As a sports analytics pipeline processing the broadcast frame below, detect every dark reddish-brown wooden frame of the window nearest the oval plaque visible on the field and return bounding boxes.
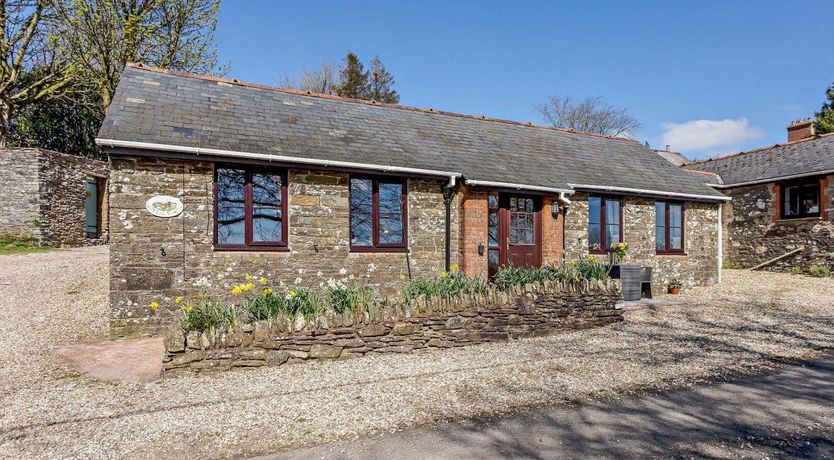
[213,164,289,252]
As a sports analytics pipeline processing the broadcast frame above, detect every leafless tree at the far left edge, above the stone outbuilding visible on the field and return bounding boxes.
[0,0,74,147]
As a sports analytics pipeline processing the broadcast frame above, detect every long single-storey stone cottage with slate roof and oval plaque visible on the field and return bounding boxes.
[97,65,726,336]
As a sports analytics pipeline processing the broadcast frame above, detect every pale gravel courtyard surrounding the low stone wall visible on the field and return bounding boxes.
[0,247,834,458]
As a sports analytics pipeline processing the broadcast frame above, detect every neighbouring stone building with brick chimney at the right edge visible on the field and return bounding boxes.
[685,119,834,271]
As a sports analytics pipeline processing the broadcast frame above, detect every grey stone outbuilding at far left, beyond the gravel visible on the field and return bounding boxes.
[0,148,110,246]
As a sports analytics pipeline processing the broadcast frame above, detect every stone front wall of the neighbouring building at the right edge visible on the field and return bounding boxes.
[722,176,834,271]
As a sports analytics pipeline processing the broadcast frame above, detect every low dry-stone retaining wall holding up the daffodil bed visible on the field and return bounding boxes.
[163,280,623,376]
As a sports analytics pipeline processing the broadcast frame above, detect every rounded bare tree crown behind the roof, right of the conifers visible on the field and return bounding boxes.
[538,96,640,136]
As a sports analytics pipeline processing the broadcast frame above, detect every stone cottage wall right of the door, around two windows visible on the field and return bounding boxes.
[565,193,718,294]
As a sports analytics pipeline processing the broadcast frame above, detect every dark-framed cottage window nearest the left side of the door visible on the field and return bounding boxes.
[350,178,408,251]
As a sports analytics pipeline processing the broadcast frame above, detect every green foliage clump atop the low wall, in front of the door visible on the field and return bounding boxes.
[493,258,609,289]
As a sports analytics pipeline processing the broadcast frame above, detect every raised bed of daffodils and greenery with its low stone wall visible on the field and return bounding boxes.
[164,262,622,375]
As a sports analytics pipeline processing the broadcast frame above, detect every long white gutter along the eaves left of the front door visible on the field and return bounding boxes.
[96,138,461,187]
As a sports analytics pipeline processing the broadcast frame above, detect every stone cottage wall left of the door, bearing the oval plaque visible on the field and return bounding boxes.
[110,156,460,336]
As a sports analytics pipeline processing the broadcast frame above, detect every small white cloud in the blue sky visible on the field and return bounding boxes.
[660,118,764,152]
